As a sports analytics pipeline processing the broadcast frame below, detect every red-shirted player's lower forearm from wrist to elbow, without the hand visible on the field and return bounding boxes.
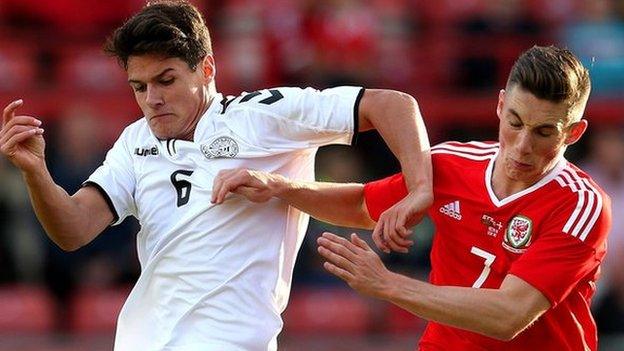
[381,273,536,340]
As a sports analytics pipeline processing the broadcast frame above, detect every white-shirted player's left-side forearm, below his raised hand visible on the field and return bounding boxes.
[22,166,95,251]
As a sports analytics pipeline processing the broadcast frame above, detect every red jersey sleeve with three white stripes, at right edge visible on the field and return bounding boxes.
[509,193,611,307]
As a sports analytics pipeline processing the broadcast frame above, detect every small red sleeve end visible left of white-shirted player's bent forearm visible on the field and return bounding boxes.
[364,173,407,221]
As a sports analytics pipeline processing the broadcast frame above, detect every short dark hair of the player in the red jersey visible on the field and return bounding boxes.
[507,45,591,108]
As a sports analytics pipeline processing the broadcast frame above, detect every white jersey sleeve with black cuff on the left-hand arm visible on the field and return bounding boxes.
[83,130,136,225]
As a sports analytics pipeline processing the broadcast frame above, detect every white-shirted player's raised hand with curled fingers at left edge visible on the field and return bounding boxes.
[0,99,45,171]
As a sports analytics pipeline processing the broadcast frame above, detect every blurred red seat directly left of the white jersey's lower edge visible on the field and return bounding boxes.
[69,289,129,334]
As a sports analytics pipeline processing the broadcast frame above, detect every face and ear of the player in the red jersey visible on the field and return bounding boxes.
[495,87,587,187]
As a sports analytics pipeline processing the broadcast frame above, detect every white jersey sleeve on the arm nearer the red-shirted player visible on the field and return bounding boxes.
[226,86,364,151]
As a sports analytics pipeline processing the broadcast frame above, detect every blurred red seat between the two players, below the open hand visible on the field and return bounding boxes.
[284,288,372,336]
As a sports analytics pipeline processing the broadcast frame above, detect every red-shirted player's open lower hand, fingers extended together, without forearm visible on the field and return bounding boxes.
[317,233,391,298]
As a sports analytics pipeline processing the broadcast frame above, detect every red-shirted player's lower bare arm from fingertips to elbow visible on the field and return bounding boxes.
[318,233,550,340]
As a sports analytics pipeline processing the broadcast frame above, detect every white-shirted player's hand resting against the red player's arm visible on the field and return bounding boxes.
[373,191,432,253]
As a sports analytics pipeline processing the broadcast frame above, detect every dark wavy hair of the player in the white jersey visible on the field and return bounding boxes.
[104,1,212,70]
